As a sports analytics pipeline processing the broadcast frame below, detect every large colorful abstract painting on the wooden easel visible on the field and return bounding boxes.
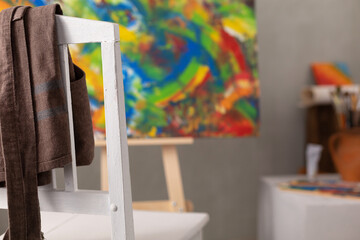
[0,0,260,138]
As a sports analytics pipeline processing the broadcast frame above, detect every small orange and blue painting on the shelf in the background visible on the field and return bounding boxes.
[311,62,353,85]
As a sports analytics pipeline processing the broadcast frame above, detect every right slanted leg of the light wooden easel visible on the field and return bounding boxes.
[162,145,187,212]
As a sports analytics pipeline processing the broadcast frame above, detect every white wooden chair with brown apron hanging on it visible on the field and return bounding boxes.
[0,16,208,240]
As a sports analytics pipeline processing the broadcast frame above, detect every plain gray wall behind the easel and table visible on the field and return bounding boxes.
[0,0,360,240]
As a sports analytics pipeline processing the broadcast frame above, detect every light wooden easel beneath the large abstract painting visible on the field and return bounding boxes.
[95,138,194,212]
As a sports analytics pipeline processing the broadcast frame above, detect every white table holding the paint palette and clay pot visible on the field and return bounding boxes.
[258,175,360,240]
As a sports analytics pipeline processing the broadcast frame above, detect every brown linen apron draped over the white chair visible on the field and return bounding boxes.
[0,5,94,240]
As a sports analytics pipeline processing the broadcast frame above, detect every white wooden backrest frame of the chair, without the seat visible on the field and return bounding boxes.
[0,16,134,240]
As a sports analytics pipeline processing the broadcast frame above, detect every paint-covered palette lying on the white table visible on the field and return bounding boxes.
[279,180,360,200]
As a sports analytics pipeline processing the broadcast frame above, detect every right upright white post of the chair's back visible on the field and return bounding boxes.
[101,40,135,240]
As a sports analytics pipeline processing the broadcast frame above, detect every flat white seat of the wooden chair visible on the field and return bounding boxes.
[1,211,209,240]
